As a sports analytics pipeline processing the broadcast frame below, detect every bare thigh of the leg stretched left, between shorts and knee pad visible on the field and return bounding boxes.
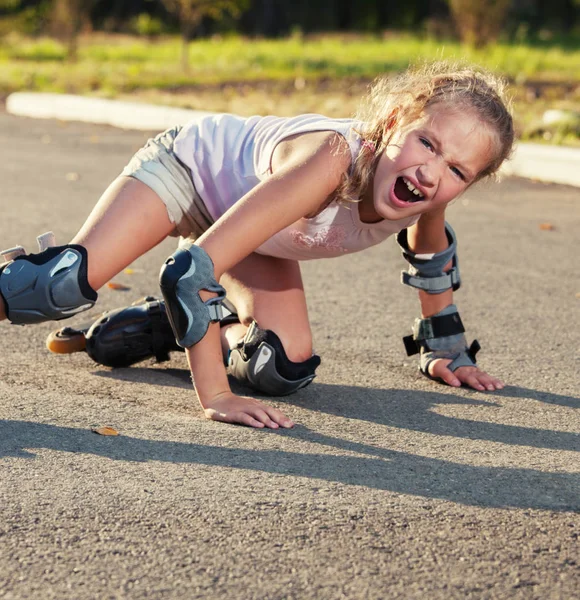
[0,177,175,320]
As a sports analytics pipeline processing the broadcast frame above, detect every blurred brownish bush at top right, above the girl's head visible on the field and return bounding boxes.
[447,0,511,48]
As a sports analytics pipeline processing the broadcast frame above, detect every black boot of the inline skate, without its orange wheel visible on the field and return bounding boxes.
[86,296,183,367]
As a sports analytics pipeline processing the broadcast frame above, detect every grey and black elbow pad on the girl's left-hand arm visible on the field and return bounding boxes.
[159,244,226,348]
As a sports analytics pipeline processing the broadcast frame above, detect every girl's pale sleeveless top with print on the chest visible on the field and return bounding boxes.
[174,114,417,260]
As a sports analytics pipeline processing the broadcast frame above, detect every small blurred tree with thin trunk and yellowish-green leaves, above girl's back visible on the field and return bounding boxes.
[162,0,250,71]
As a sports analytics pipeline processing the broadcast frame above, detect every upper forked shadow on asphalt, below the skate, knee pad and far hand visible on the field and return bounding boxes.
[97,367,580,452]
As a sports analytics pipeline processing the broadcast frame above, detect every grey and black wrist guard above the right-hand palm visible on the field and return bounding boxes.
[403,304,481,380]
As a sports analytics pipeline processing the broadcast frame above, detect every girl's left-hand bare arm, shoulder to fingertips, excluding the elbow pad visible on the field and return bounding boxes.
[187,132,350,427]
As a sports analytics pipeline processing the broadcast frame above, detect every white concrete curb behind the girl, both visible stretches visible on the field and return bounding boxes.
[6,92,580,187]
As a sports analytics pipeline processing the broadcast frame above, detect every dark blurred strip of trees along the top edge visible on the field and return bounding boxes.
[0,0,580,44]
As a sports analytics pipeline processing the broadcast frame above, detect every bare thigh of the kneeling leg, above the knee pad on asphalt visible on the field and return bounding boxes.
[220,253,312,362]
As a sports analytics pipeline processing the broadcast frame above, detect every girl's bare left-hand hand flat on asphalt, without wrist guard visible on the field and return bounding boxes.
[203,392,294,429]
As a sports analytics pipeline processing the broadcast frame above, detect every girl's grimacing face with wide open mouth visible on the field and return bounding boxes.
[360,106,493,221]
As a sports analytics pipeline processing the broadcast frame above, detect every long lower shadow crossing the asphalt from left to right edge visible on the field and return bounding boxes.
[0,420,580,511]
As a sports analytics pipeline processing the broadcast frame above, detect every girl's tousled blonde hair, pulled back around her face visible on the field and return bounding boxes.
[336,61,515,202]
